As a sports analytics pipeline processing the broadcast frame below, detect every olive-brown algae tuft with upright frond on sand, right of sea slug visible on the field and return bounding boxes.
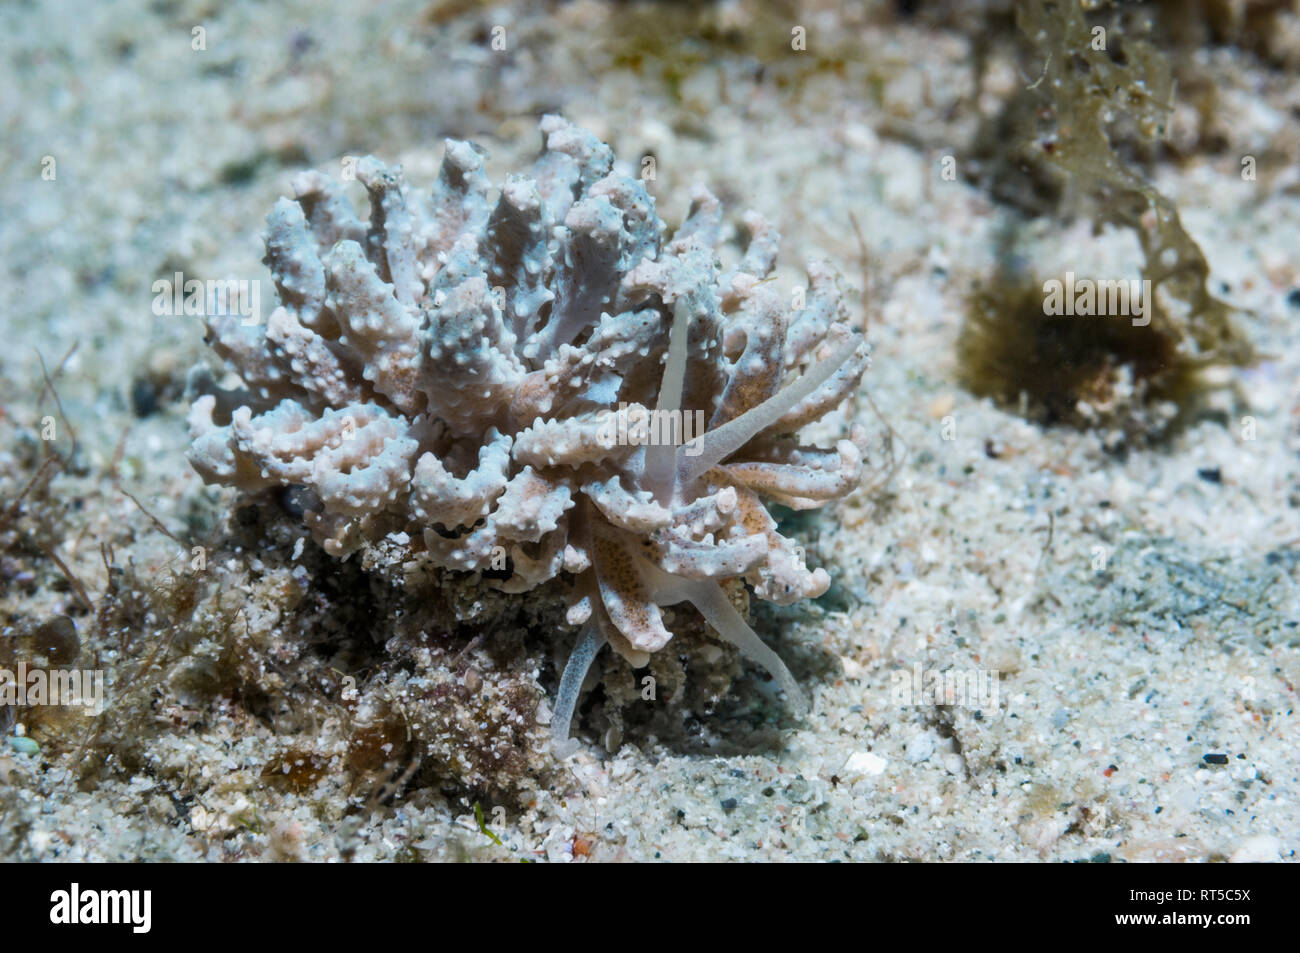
[959,0,1255,442]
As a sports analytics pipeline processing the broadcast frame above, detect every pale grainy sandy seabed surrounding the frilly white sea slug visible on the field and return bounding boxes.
[0,0,1300,861]
